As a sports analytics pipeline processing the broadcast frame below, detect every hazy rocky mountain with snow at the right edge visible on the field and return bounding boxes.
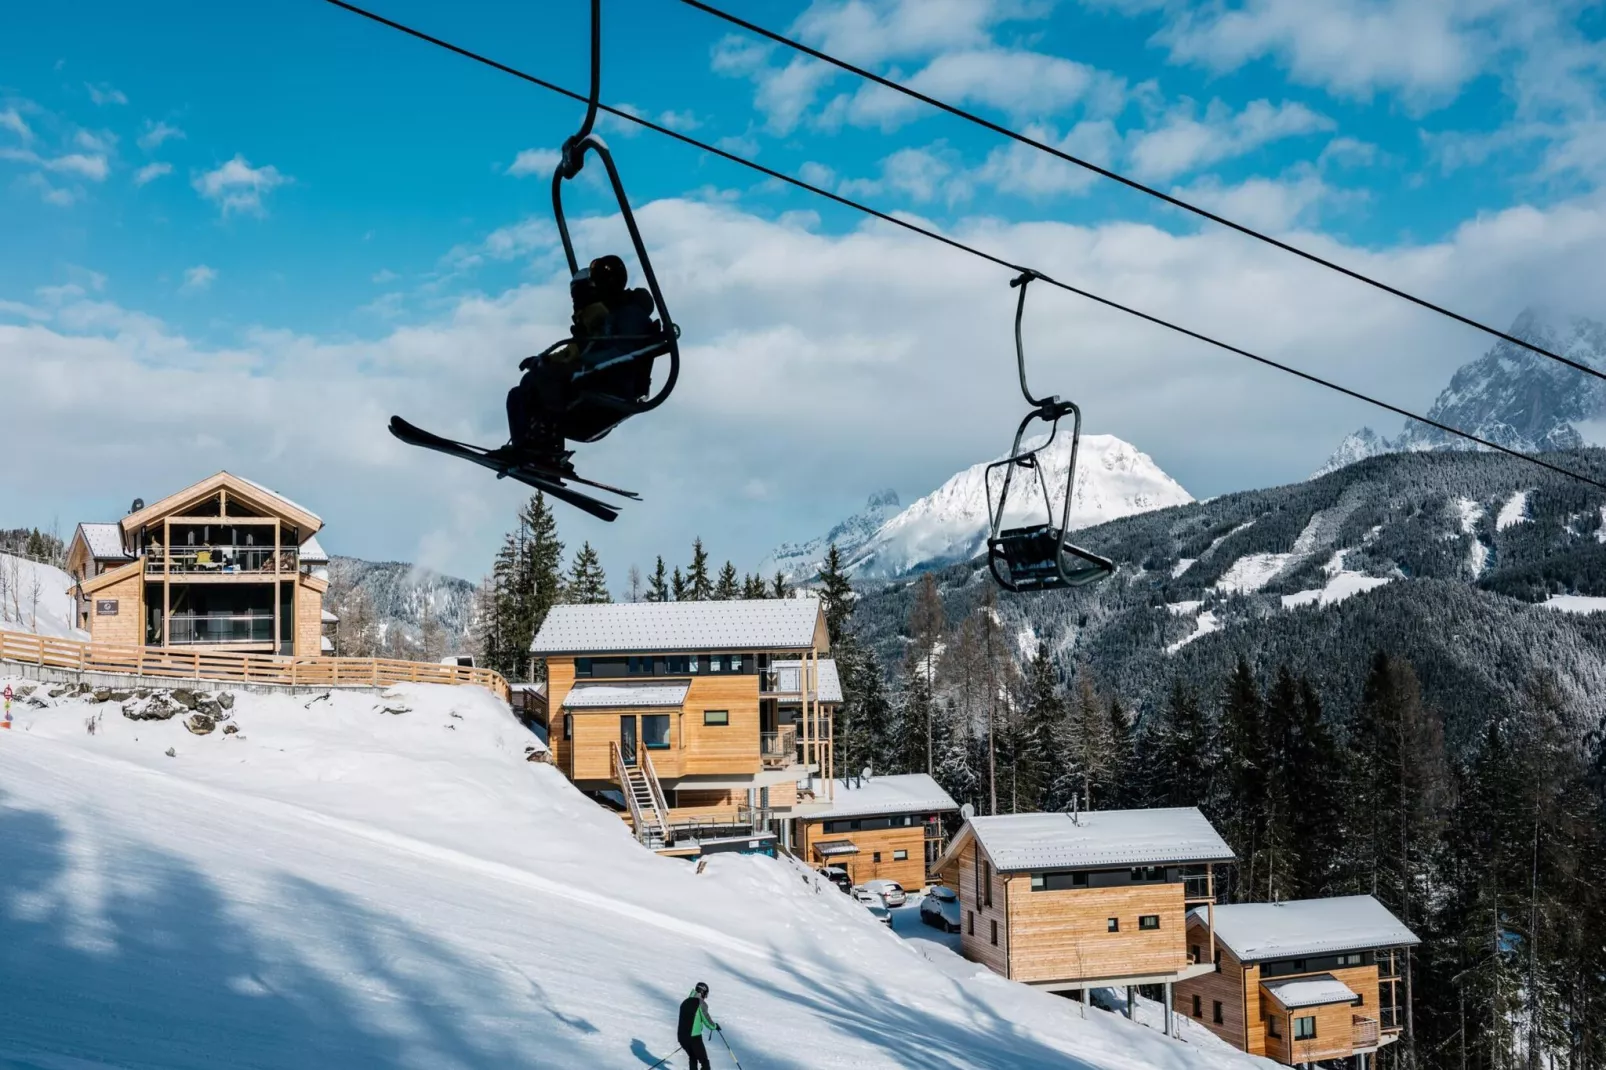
[1315,308,1606,476]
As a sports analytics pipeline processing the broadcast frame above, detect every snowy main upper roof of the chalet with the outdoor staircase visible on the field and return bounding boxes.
[530,598,819,654]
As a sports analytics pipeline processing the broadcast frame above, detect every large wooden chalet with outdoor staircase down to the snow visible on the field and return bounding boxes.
[530,598,840,855]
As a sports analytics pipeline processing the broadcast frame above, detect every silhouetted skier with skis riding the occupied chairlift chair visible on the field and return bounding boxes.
[390,0,681,521]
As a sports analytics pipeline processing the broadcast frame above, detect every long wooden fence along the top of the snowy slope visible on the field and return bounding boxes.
[0,631,509,700]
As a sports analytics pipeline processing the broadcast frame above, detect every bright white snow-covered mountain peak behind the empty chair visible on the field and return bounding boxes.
[848,435,1193,580]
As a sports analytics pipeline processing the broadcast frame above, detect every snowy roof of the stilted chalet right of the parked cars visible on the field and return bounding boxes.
[970,807,1233,873]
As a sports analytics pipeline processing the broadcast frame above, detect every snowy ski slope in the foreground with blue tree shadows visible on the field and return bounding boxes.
[0,677,1270,1070]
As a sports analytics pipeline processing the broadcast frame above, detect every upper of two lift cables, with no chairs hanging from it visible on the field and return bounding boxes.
[679,0,1606,387]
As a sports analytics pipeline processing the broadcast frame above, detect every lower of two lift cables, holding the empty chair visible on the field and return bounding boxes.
[313,0,1606,490]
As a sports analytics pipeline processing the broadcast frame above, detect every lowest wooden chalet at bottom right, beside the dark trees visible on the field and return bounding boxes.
[1176,895,1418,1067]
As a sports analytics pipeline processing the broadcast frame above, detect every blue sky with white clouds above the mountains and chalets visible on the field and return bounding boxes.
[0,0,1606,577]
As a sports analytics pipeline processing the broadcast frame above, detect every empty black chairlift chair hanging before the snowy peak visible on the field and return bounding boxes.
[983,272,1115,591]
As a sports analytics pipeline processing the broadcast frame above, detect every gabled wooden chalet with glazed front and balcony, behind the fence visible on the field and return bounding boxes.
[67,472,329,657]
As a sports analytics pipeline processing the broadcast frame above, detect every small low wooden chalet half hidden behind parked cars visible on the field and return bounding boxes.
[795,773,959,892]
